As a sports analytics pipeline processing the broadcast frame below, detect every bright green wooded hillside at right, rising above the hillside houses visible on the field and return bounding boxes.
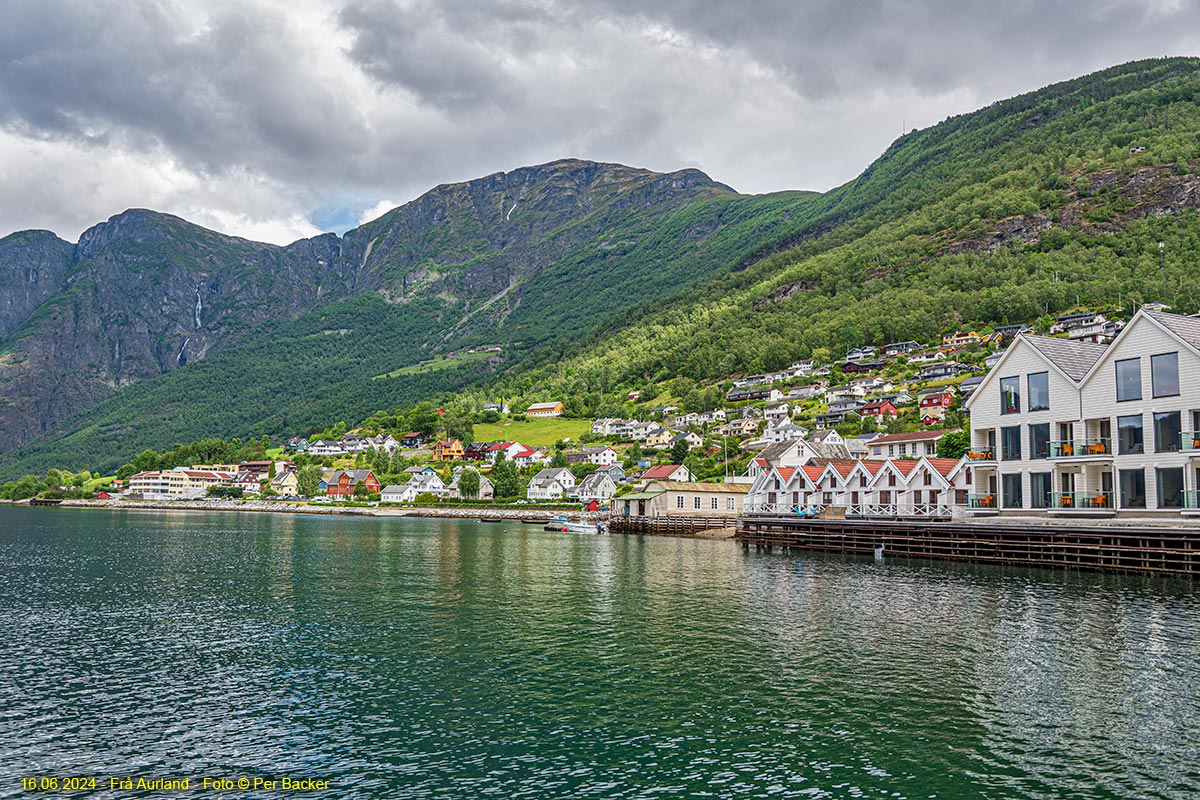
[484,59,1200,413]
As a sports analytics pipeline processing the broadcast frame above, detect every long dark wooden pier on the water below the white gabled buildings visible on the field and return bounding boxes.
[736,517,1200,576]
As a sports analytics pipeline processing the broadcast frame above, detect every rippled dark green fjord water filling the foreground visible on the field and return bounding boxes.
[0,509,1200,799]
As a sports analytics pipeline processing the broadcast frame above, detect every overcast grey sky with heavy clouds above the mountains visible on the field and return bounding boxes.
[0,0,1200,242]
